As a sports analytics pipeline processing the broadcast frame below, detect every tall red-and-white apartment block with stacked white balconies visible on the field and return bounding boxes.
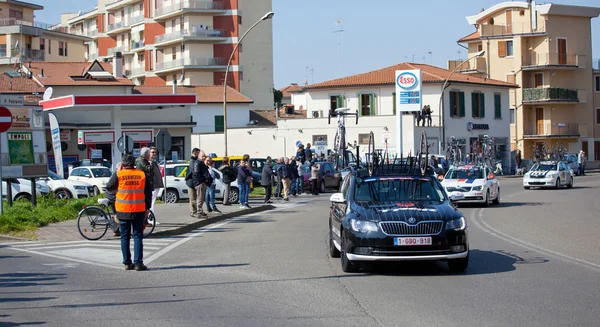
[63,0,273,108]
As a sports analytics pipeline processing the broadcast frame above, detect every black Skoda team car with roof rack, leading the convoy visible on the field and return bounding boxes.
[329,132,469,272]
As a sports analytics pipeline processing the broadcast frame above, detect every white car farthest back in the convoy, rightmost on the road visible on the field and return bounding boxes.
[523,161,575,190]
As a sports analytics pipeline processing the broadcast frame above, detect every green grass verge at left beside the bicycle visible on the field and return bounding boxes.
[0,196,103,238]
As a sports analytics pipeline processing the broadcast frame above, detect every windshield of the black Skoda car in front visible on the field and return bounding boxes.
[354,177,445,202]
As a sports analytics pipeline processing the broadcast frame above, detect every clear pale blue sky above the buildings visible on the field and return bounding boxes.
[30,0,600,88]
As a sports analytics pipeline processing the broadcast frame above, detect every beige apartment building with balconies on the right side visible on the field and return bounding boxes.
[448,1,600,160]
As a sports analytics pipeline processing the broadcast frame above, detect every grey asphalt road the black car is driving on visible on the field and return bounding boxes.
[0,175,600,326]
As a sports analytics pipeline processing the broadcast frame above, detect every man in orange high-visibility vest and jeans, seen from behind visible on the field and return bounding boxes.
[106,155,152,271]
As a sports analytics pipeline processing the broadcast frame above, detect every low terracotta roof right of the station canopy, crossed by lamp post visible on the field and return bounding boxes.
[133,85,254,103]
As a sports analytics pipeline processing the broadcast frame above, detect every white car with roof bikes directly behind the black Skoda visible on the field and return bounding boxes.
[442,165,500,206]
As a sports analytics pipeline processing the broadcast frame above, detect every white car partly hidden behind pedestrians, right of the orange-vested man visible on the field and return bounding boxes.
[157,163,246,204]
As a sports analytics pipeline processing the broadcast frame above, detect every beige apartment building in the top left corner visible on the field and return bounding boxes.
[0,0,89,72]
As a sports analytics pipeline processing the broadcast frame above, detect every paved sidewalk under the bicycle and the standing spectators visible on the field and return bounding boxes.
[32,198,276,242]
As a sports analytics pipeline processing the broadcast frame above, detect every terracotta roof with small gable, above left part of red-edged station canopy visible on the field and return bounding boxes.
[27,61,135,86]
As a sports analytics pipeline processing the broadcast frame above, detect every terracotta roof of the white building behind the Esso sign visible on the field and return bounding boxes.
[304,63,519,90]
